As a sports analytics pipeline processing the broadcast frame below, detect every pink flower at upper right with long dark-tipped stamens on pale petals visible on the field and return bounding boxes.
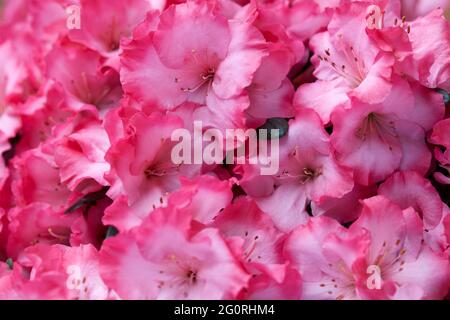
[295,1,394,123]
